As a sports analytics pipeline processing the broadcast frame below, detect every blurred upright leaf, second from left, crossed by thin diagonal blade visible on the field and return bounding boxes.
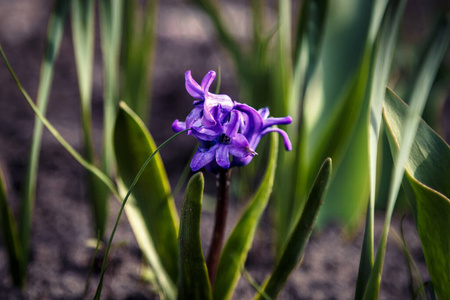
[71,0,108,237]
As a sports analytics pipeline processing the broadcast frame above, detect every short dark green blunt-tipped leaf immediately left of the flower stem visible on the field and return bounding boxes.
[178,173,212,299]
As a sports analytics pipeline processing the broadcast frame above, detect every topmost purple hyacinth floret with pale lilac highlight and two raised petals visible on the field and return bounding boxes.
[185,71,234,127]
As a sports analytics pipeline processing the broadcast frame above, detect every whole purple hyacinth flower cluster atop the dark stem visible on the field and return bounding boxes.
[172,71,292,173]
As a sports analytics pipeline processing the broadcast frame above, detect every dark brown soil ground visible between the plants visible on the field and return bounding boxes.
[0,0,448,299]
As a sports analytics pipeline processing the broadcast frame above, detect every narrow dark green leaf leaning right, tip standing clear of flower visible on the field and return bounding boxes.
[257,158,332,299]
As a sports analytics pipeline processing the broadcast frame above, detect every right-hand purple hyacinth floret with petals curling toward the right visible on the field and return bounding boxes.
[233,103,292,166]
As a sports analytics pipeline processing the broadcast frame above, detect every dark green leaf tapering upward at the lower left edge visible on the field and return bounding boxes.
[0,168,26,287]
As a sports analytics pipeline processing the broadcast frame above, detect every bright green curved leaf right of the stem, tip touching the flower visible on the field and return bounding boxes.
[213,134,278,300]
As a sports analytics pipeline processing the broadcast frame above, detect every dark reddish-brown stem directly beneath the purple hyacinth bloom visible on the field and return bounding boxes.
[207,169,231,286]
